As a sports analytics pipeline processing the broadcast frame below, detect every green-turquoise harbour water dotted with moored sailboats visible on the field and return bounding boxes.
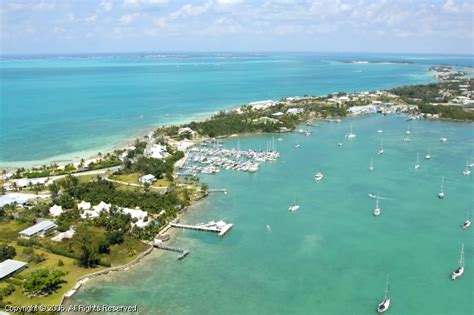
[70,115,474,315]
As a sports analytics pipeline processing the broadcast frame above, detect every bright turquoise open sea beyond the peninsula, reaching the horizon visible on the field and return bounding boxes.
[0,54,473,166]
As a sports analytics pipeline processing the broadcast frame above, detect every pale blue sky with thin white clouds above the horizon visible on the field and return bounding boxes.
[0,0,474,54]
